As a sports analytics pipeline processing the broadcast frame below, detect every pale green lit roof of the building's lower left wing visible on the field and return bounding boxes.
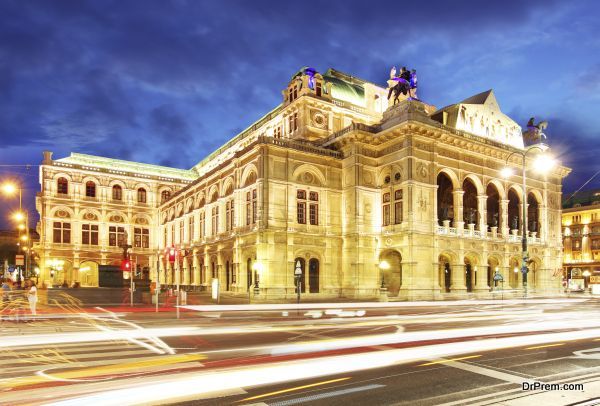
[55,152,198,180]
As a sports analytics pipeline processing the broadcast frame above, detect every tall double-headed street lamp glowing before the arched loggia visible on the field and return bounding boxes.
[501,143,555,295]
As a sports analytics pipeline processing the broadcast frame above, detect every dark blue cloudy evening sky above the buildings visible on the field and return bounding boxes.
[0,0,600,228]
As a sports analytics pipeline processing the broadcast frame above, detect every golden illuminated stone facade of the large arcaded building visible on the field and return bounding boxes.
[39,68,568,299]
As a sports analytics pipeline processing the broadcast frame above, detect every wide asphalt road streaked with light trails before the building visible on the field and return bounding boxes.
[0,299,600,405]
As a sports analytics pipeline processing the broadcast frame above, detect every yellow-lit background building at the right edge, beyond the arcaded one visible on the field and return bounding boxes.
[562,189,600,290]
